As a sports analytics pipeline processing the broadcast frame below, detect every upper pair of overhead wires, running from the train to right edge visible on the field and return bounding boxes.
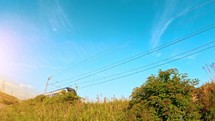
[48,24,215,86]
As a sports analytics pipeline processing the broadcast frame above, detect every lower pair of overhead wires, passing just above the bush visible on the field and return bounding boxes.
[79,41,215,89]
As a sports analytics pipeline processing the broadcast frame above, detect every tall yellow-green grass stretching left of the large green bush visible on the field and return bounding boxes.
[0,96,129,121]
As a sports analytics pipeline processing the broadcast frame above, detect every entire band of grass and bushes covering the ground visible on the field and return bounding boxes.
[0,69,215,121]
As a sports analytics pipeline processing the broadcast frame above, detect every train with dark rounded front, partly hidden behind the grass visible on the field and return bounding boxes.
[44,87,77,97]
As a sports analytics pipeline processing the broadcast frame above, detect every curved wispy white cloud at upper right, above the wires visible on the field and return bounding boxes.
[151,0,214,48]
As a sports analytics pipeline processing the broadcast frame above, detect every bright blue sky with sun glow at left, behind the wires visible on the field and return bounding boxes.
[0,0,215,98]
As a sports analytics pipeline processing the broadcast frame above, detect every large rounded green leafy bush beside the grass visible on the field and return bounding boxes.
[128,69,200,121]
